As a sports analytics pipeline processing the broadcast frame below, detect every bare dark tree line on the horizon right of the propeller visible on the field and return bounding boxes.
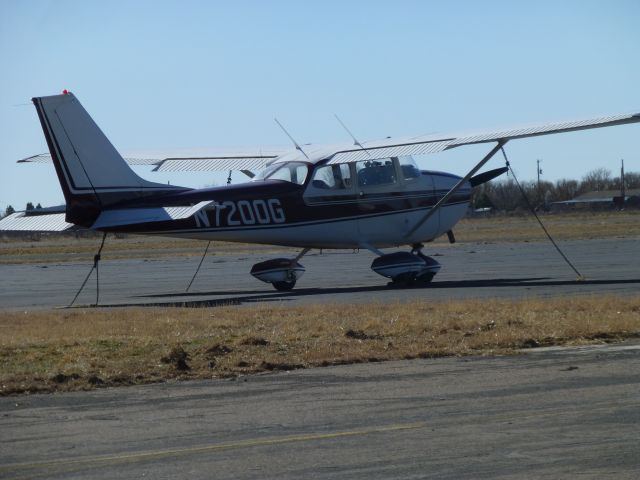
[471,168,640,212]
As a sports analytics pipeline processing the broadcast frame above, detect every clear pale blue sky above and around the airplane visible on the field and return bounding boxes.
[0,0,640,210]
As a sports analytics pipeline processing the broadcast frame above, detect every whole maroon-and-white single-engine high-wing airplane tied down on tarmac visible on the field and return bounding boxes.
[3,90,640,290]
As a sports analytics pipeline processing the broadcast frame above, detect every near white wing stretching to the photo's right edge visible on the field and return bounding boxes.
[328,113,640,164]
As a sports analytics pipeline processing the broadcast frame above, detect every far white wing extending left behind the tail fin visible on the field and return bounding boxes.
[18,148,291,172]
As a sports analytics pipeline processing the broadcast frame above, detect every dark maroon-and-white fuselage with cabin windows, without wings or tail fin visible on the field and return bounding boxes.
[102,158,471,248]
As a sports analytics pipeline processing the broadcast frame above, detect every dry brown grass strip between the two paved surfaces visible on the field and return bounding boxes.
[0,296,640,395]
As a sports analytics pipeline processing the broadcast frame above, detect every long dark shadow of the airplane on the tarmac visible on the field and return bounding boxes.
[87,277,640,308]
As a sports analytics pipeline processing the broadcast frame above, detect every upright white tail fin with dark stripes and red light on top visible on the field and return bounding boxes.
[32,91,184,227]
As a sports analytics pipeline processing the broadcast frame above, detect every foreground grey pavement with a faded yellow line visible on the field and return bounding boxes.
[0,344,640,479]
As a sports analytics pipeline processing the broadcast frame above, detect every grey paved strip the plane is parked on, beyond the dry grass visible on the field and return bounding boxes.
[0,238,640,309]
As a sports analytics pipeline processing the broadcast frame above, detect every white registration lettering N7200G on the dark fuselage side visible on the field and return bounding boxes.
[204,198,286,227]
